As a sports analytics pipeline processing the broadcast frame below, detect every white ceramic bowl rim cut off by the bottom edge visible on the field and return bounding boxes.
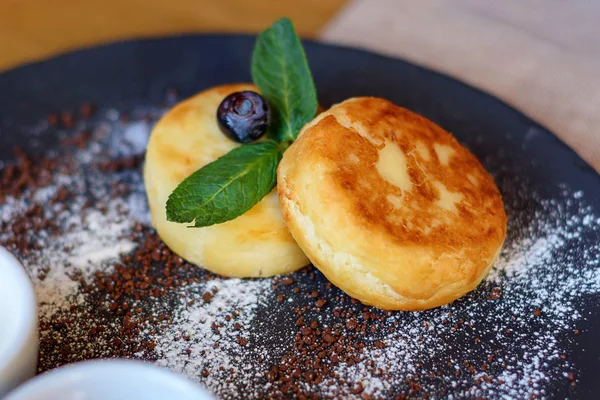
[4,360,214,400]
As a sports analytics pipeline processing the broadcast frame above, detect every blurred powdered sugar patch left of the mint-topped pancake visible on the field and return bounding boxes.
[0,110,149,319]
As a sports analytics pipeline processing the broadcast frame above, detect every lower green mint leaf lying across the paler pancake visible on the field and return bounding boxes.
[167,142,283,228]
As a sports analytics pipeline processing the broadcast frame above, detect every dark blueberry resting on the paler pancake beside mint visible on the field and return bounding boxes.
[217,90,270,143]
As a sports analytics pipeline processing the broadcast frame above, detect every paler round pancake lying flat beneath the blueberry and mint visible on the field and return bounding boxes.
[144,84,309,277]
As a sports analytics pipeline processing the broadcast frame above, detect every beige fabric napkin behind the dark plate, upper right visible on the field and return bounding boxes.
[322,0,600,172]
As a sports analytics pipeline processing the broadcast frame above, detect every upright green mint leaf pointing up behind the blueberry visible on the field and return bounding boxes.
[251,18,318,142]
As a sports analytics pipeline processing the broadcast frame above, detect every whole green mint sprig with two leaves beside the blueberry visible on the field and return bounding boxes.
[166,18,317,228]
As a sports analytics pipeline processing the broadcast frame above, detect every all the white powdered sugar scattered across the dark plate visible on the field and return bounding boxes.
[0,110,600,398]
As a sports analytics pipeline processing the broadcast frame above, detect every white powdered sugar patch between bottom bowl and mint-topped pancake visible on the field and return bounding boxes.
[156,279,271,397]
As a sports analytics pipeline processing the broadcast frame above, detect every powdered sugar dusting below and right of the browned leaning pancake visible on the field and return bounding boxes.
[292,190,600,398]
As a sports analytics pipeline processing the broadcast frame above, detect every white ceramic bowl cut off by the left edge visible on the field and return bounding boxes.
[0,247,38,398]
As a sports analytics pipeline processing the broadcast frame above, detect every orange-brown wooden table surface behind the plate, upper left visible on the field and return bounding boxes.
[0,0,347,71]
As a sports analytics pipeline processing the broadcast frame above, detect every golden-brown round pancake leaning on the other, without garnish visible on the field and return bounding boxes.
[277,97,506,310]
